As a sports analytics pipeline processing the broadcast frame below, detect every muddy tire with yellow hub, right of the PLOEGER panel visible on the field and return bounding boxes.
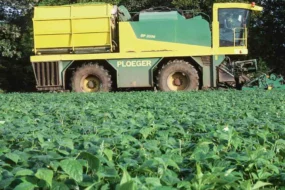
[157,60,199,91]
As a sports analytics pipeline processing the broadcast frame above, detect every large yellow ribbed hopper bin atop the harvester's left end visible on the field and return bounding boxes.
[33,4,113,52]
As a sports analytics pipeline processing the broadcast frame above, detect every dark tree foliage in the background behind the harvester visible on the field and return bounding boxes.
[0,0,285,92]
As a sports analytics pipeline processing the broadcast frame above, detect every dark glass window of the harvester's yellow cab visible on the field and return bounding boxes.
[218,8,250,47]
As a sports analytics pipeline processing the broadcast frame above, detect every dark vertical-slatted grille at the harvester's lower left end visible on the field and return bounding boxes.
[33,62,62,90]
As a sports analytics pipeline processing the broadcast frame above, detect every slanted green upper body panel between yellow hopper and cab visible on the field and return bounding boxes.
[130,13,212,47]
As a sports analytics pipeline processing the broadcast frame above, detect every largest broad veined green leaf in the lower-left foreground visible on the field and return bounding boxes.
[60,159,83,182]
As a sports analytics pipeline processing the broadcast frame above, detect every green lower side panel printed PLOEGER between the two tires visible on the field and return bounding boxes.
[107,58,160,88]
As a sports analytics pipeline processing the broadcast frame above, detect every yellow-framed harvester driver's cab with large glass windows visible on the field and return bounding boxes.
[212,3,263,55]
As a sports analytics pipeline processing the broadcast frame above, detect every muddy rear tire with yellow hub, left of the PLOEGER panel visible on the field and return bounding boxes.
[71,64,112,92]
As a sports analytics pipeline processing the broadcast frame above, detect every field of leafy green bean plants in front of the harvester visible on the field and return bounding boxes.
[0,91,285,190]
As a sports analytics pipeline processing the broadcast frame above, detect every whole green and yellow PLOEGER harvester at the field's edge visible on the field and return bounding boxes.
[31,3,284,92]
